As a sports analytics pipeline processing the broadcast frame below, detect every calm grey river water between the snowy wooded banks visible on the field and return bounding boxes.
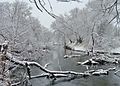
[31,47,120,86]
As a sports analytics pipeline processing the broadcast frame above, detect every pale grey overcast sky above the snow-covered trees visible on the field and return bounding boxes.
[0,0,88,28]
